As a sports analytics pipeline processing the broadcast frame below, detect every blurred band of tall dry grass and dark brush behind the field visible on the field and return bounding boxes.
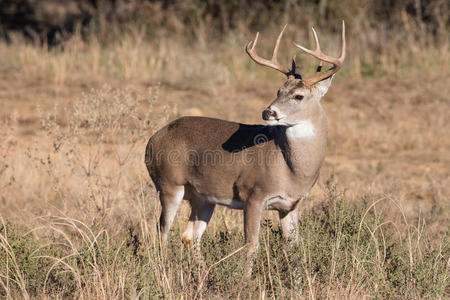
[0,0,449,85]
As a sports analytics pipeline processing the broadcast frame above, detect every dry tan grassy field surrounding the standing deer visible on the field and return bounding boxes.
[0,1,450,299]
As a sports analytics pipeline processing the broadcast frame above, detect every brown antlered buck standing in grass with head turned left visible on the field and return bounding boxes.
[145,21,346,255]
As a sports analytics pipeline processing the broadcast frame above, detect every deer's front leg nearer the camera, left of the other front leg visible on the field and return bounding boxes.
[244,196,263,277]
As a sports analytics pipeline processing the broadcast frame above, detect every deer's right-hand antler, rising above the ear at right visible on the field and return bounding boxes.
[294,20,345,86]
